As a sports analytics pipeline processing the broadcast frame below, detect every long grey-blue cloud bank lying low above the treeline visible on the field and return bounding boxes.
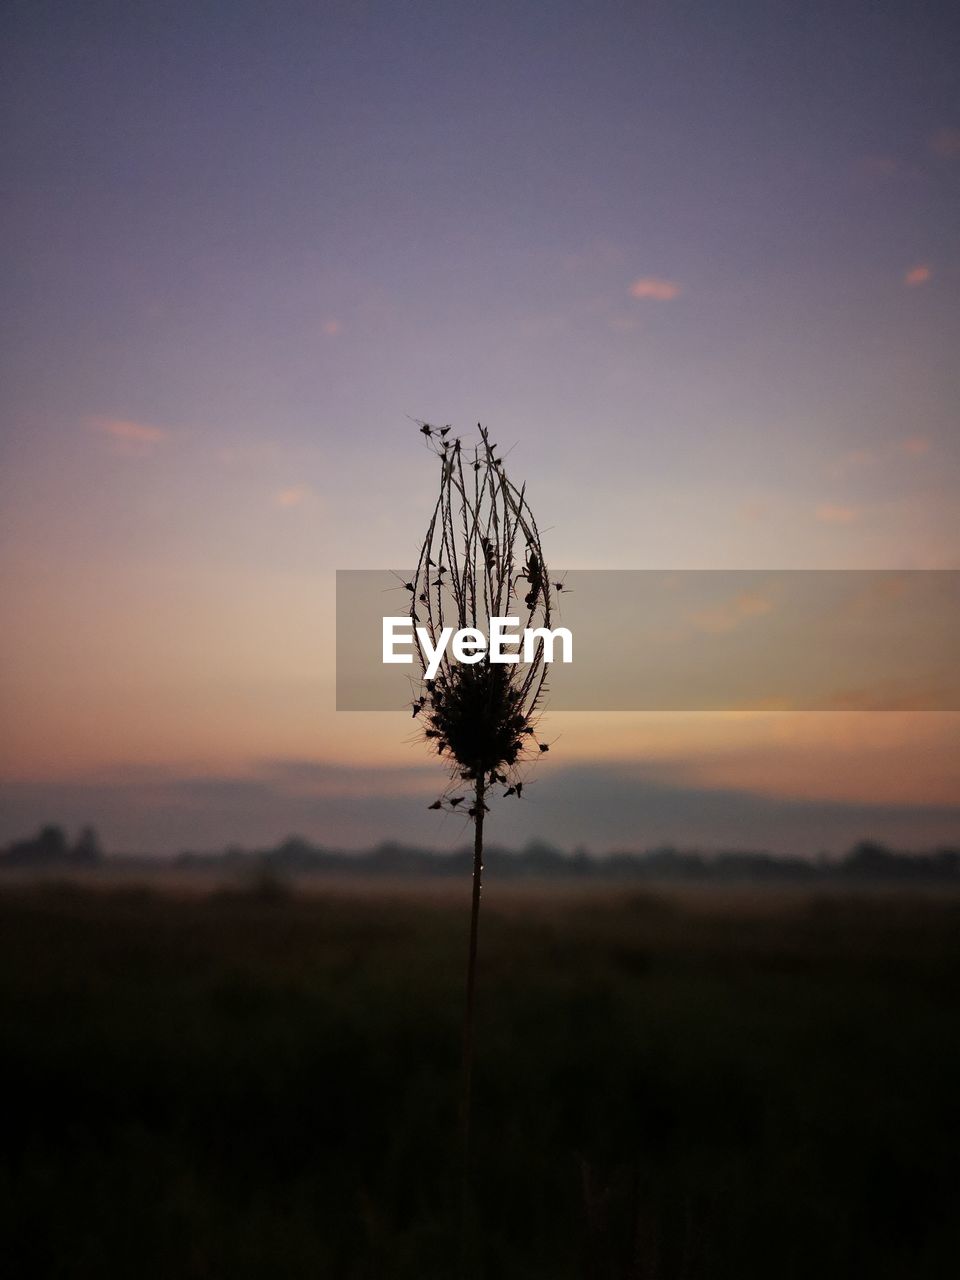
[0,757,960,854]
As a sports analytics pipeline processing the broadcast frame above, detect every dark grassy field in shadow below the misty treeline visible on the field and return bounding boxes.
[0,868,960,1280]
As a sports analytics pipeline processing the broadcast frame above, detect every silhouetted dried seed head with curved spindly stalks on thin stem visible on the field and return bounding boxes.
[404,422,562,1239]
